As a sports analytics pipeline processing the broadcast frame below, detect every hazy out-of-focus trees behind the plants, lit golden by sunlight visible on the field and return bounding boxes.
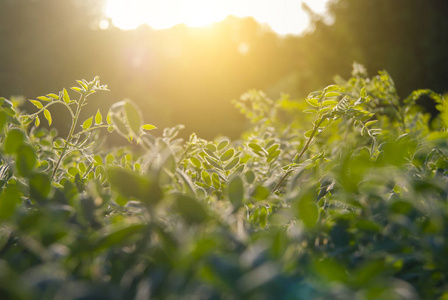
[0,0,448,138]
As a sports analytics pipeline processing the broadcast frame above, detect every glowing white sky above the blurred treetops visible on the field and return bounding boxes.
[105,0,328,35]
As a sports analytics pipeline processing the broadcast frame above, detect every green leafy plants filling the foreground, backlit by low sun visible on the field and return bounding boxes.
[0,64,448,299]
